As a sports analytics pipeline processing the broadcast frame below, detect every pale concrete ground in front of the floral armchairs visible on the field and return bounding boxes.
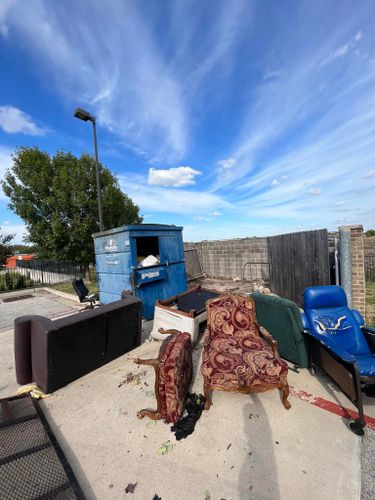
[42,342,360,500]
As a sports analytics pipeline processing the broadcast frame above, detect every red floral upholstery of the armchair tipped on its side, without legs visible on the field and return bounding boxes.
[158,333,193,423]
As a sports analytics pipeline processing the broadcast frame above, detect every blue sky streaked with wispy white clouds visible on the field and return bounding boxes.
[0,0,375,241]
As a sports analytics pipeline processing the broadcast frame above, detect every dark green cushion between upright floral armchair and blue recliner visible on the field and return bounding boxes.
[251,292,309,368]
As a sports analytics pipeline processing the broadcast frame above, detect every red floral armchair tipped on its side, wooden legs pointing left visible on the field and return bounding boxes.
[134,328,193,423]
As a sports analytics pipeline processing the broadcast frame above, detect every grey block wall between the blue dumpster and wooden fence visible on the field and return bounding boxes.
[184,237,269,280]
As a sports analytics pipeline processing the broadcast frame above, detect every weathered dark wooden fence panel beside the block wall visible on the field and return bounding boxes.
[268,229,330,305]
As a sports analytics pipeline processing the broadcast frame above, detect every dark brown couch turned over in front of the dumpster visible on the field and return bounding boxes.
[14,297,142,393]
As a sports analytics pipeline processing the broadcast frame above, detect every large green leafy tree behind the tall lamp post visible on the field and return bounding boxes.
[2,147,142,264]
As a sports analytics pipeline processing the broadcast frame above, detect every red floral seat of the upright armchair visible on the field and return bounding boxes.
[201,331,288,390]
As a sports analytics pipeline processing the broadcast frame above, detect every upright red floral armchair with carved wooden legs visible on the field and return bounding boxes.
[201,294,290,410]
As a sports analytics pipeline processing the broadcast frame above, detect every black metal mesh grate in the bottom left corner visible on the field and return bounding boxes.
[0,396,84,500]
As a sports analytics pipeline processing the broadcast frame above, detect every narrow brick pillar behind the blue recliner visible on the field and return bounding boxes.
[350,225,366,317]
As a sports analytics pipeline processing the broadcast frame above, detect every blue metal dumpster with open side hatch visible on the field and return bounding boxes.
[93,224,187,319]
